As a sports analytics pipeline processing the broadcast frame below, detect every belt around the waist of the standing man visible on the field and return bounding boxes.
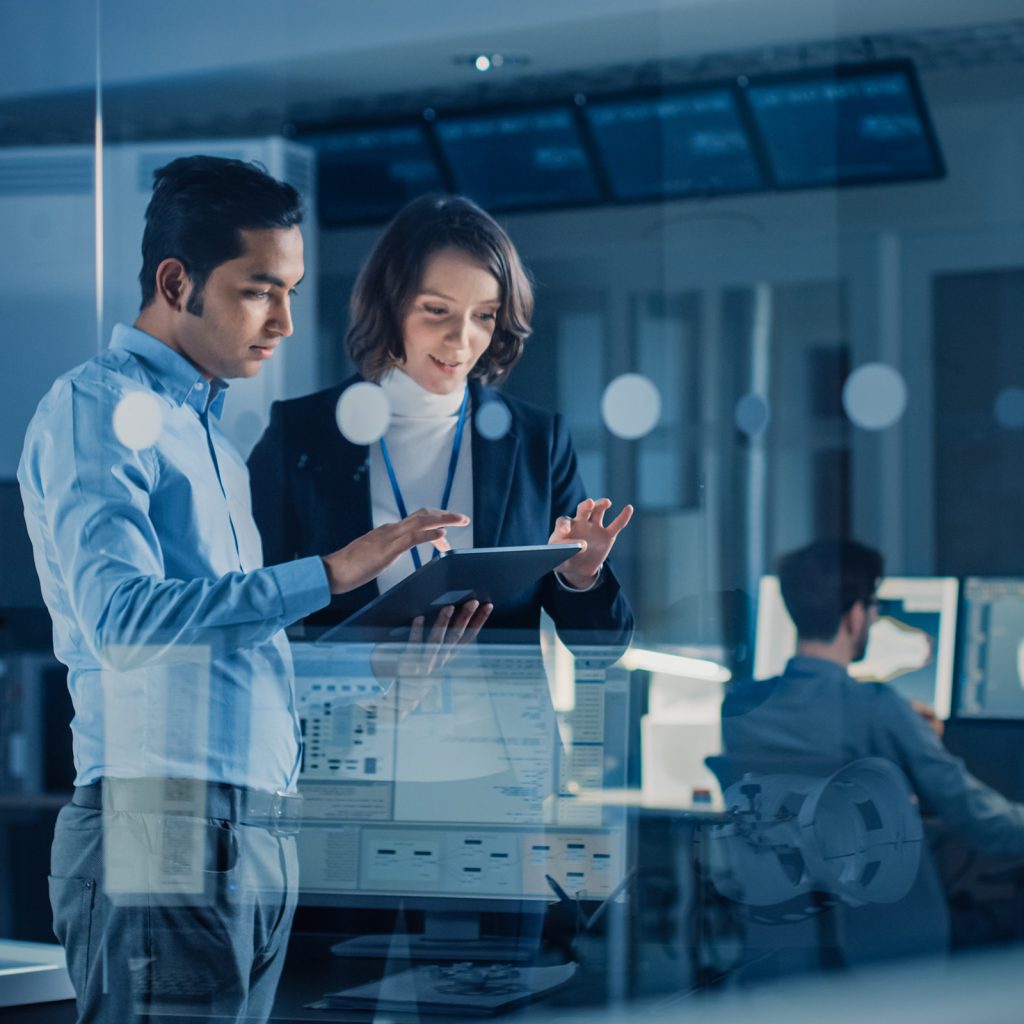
[72,778,302,836]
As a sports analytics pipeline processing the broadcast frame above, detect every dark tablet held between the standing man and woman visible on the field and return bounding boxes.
[322,543,584,640]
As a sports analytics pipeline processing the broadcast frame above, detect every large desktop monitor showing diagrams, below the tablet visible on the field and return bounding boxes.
[295,643,629,959]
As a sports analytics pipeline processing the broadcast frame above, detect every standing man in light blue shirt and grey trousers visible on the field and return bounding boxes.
[18,157,484,1024]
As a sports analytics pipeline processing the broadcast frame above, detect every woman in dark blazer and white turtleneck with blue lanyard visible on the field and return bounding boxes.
[249,196,633,645]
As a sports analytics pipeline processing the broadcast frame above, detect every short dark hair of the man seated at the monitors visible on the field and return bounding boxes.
[778,541,884,641]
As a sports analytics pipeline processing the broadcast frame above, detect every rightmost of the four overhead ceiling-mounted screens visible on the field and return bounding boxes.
[743,62,944,188]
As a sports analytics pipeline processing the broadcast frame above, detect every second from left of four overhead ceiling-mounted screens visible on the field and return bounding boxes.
[434,108,600,210]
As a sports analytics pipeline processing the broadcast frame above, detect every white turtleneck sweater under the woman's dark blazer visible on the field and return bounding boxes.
[370,369,473,594]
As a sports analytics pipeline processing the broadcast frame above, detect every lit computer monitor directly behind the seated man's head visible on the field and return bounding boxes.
[754,575,958,719]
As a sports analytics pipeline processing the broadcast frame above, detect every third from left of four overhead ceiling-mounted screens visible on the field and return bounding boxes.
[584,87,764,201]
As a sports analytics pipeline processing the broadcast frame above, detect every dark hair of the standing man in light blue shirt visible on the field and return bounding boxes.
[138,157,302,316]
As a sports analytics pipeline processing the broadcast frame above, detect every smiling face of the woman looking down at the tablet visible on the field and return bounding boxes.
[401,249,502,394]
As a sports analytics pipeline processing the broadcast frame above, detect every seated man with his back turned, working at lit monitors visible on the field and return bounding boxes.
[722,541,1024,959]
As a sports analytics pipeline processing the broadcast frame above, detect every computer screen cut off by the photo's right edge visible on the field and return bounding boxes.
[955,577,1024,719]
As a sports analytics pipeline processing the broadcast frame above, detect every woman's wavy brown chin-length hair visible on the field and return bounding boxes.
[345,196,534,384]
